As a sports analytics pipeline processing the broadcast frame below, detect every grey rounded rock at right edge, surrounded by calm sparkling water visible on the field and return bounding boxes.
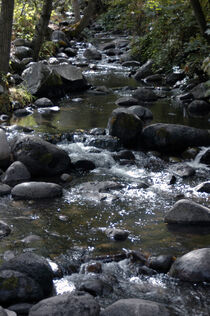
[164,199,210,225]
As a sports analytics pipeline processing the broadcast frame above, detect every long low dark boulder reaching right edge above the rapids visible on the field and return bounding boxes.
[139,123,210,153]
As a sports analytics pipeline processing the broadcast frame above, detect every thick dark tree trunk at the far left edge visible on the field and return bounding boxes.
[0,0,14,81]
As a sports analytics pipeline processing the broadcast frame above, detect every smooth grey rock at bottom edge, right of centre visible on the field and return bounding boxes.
[100,298,171,316]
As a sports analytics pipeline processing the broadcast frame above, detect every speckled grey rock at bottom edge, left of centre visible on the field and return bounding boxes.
[29,292,100,316]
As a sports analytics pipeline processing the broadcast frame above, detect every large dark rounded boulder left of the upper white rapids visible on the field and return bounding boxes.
[12,135,71,177]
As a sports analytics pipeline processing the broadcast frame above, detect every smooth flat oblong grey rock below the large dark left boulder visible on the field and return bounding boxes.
[11,182,63,200]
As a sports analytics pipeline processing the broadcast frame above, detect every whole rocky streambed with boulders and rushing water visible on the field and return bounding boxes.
[0,25,210,316]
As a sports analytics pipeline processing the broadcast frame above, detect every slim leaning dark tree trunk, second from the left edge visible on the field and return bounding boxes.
[33,0,53,61]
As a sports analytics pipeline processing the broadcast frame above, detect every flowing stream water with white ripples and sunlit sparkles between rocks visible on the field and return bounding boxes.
[0,34,210,316]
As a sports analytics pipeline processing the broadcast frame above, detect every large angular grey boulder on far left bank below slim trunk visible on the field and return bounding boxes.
[22,62,87,97]
